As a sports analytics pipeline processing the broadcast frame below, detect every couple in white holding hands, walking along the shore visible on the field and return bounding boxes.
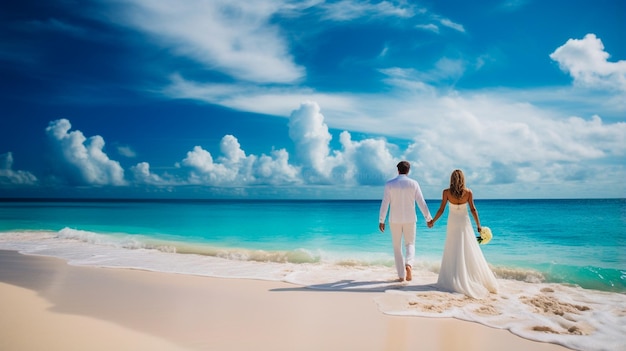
[378,161,498,298]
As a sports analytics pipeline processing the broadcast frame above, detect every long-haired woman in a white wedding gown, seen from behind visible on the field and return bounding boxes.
[428,169,498,298]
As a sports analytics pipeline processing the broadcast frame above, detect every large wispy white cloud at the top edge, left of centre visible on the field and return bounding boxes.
[108,0,305,83]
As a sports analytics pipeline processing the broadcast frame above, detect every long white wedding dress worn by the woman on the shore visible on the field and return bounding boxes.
[437,203,498,298]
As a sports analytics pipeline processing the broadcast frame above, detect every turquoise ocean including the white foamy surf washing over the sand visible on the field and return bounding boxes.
[0,199,626,350]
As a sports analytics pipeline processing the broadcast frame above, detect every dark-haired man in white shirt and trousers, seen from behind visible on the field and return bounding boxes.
[378,161,432,282]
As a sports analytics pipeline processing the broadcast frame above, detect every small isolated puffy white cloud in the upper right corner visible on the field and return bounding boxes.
[550,34,626,92]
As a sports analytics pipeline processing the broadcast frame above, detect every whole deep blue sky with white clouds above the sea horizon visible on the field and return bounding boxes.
[0,0,626,199]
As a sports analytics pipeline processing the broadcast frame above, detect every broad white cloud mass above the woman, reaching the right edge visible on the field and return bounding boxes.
[404,92,626,182]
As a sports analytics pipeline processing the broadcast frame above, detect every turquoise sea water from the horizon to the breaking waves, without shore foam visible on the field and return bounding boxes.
[0,199,626,292]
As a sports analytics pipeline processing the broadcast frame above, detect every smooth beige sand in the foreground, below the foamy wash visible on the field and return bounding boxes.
[0,251,567,351]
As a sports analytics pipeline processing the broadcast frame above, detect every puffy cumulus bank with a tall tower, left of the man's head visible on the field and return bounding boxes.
[165,101,398,187]
